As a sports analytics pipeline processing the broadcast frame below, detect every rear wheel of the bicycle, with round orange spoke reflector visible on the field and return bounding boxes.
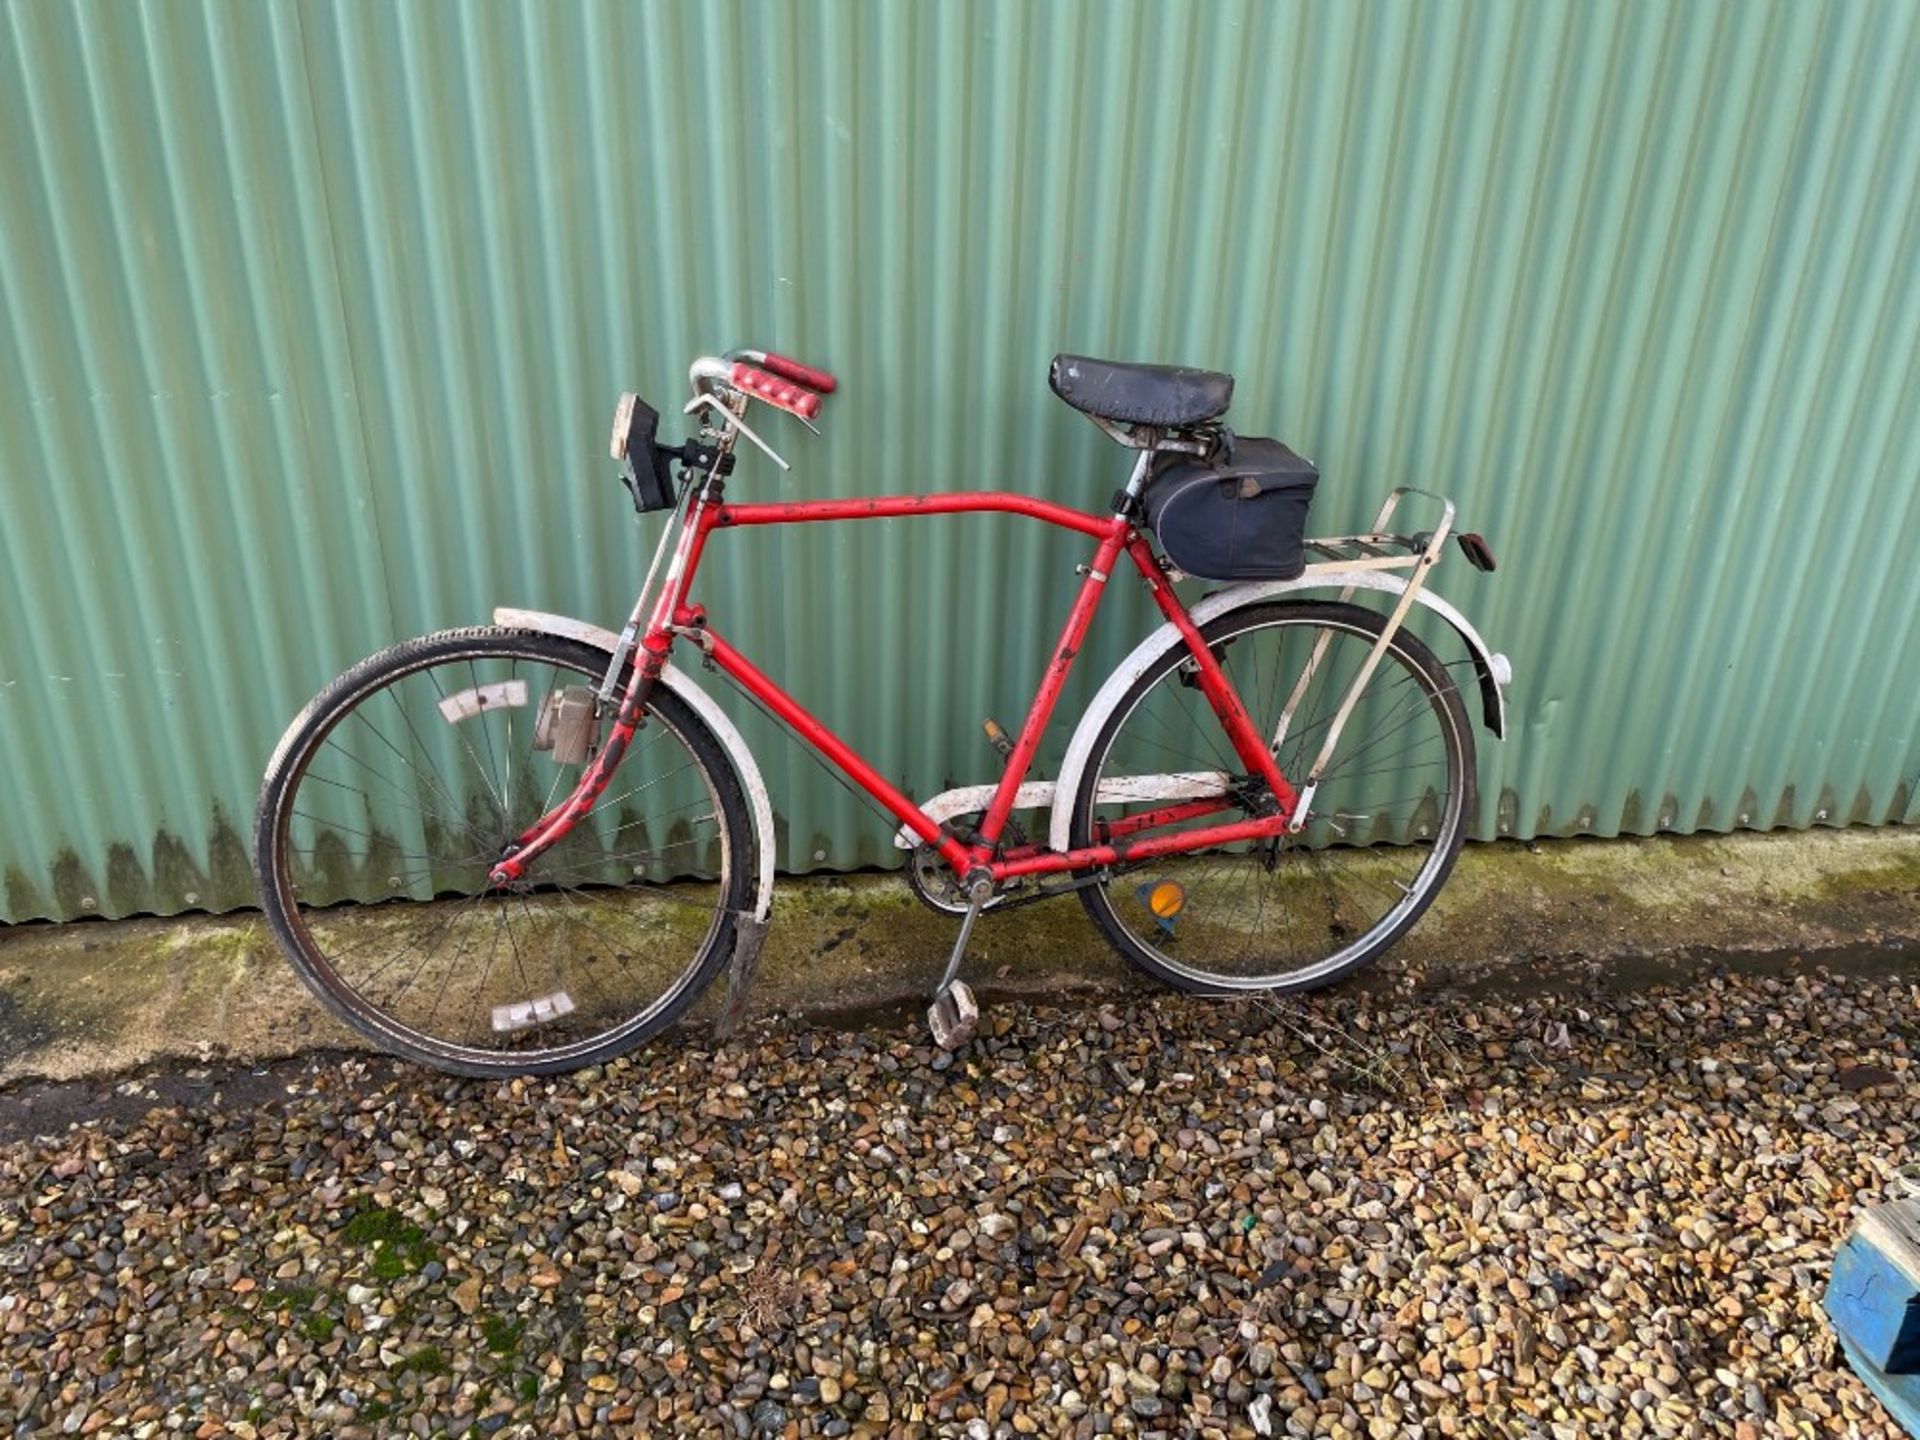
[1071,601,1475,995]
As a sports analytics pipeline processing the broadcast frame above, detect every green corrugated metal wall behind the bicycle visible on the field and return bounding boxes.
[0,0,1920,920]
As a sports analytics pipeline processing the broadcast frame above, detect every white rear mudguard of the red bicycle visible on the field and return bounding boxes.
[1044,570,1513,851]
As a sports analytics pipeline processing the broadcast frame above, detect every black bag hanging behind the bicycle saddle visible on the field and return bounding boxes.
[1146,436,1319,580]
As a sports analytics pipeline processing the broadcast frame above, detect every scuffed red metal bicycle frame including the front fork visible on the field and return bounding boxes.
[493,480,1298,885]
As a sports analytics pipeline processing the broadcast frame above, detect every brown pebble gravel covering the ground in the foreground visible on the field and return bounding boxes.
[0,972,1920,1438]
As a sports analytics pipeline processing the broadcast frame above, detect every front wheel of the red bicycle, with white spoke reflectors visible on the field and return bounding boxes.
[253,628,751,1075]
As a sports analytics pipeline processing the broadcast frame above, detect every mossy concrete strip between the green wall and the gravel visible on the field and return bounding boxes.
[0,828,1920,1081]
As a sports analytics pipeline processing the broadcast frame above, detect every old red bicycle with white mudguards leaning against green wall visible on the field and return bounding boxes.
[255,349,1511,1075]
